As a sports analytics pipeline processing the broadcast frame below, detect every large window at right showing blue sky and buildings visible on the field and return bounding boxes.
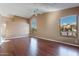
[60,15,78,37]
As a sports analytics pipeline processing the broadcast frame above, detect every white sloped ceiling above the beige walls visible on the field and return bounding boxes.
[0,3,79,18]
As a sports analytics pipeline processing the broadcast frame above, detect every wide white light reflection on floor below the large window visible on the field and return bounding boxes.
[59,46,79,56]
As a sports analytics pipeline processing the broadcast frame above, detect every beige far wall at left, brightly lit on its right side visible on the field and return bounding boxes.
[6,17,29,38]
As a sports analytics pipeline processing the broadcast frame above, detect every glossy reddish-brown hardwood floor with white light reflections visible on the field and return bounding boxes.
[0,37,79,56]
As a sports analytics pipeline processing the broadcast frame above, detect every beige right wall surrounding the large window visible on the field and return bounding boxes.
[31,7,79,44]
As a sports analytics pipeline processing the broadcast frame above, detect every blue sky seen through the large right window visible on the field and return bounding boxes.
[60,15,76,25]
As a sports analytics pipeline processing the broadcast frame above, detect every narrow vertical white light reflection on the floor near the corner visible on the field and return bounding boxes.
[30,38,38,55]
